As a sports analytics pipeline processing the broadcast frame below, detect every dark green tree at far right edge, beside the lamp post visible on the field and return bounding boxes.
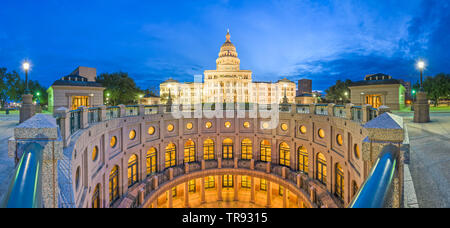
[423,73,450,107]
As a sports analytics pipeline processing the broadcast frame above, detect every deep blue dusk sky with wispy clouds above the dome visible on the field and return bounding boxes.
[0,0,450,90]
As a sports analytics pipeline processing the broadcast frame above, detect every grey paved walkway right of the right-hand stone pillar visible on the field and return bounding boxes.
[396,113,450,208]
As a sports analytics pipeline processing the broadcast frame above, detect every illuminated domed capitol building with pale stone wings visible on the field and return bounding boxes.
[160,31,296,104]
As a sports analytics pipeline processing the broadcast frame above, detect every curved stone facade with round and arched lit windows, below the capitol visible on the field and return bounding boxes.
[51,105,386,207]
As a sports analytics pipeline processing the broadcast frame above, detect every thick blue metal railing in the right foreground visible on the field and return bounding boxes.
[349,144,398,208]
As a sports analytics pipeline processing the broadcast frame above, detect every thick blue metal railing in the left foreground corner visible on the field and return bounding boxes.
[2,143,42,208]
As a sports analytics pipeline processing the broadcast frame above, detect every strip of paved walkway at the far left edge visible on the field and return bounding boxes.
[0,115,19,200]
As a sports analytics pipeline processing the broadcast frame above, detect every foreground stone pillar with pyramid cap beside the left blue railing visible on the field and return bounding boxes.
[8,114,66,208]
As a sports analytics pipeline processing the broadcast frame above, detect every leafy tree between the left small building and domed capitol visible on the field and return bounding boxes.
[97,72,143,105]
